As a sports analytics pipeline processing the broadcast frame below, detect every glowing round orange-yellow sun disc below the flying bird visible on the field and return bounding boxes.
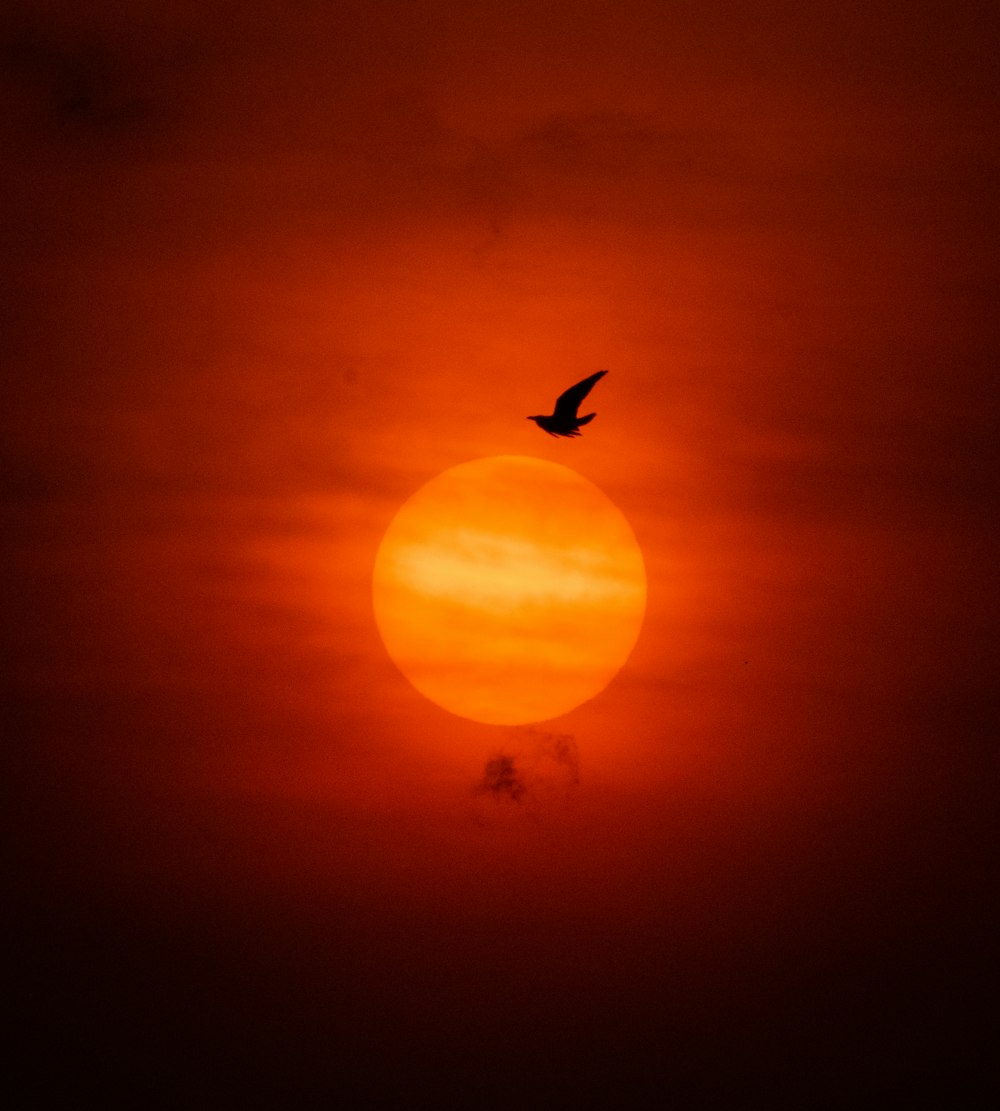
[372,456,646,725]
